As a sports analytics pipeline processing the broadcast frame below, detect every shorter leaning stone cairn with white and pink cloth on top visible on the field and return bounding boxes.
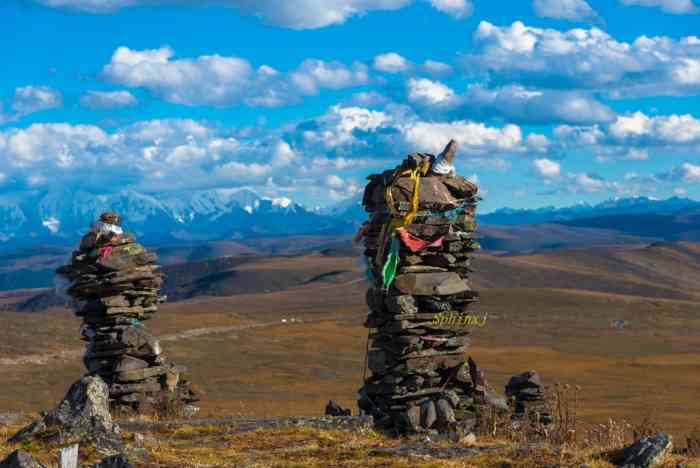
[57,213,198,411]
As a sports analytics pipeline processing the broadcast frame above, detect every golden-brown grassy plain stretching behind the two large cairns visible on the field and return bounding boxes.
[0,284,700,438]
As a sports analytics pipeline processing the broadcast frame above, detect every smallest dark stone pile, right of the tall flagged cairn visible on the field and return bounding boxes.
[506,371,552,424]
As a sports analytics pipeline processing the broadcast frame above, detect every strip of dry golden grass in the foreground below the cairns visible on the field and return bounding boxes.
[0,426,700,468]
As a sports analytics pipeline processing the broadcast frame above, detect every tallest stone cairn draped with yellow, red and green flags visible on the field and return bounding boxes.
[358,141,486,434]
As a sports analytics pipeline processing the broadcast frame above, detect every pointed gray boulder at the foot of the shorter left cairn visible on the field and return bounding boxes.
[10,376,119,445]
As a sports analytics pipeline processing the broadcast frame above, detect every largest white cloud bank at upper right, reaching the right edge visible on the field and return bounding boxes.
[464,21,700,98]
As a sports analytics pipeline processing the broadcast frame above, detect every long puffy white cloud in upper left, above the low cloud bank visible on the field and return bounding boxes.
[102,47,369,107]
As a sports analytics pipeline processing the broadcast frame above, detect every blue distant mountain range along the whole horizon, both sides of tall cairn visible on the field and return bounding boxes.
[0,189,700,247]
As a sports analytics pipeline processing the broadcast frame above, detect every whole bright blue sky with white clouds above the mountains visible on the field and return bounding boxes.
[0,0,700,210]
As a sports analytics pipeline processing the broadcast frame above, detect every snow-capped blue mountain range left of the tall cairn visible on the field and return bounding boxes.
[0,189,353,246]
